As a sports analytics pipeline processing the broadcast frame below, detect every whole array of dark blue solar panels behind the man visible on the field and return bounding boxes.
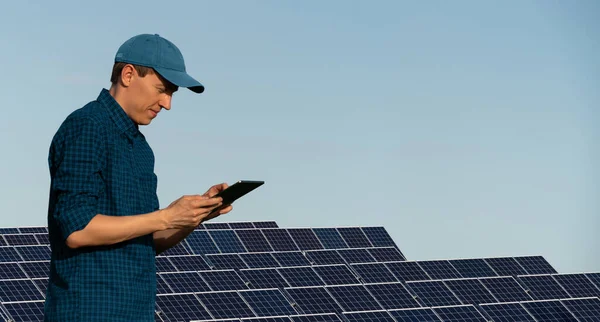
[0,221,600,322]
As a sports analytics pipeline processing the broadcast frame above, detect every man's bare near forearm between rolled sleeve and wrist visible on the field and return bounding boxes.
[66,210,166,248]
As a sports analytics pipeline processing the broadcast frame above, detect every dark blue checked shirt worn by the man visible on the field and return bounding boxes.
[45,89,159,322]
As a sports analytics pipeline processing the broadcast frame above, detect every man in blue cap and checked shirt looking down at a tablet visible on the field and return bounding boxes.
[45,34,232,322]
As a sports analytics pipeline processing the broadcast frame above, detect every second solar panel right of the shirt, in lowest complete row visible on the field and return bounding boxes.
[196,291,255,319]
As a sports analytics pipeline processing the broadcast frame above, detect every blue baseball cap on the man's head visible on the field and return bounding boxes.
[115,34,204,93]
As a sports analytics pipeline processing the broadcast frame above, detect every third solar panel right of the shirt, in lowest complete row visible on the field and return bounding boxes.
[239,289,298,316]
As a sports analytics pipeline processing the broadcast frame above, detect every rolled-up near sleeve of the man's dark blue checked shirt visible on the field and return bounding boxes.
[50,118,106,240]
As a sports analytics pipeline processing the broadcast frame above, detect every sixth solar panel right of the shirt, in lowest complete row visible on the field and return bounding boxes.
[365,283,420,310]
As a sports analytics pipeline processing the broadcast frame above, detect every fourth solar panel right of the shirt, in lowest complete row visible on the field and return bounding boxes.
[285,286,342,314]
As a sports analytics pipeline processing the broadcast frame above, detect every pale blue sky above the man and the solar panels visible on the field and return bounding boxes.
[0,0,600,272]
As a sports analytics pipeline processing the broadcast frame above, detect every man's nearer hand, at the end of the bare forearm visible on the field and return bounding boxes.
[161,195,222,229]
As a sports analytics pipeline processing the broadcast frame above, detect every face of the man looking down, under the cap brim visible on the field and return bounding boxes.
[125,69,177,125]
